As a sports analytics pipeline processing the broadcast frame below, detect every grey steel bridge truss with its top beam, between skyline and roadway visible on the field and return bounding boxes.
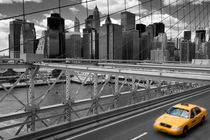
[0,63,210,139]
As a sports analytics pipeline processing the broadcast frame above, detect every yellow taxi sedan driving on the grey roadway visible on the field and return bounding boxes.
[153,103,207,135]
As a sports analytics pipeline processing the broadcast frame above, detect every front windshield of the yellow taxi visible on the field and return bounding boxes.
[167,107,189,118]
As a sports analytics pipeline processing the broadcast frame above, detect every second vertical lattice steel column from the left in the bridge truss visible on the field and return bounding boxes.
[65,70,72,121]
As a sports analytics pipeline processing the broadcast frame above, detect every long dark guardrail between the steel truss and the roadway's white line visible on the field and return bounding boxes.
[12,85,210,140]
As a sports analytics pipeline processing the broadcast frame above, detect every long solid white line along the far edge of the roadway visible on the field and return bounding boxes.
[66,91,207,140]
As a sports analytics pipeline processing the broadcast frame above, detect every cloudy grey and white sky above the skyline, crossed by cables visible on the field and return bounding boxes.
[0,0,210,55]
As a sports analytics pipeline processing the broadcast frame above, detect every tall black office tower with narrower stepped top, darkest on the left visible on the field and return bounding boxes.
[47,13,65,58]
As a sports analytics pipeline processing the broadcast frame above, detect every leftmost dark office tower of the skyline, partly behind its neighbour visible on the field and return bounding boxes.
[9,19,24,58]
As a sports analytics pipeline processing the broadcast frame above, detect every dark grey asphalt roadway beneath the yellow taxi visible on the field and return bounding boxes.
[68,88,210,140]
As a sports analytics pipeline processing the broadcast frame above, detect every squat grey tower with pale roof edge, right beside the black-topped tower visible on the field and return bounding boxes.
[66,32,82,58]
